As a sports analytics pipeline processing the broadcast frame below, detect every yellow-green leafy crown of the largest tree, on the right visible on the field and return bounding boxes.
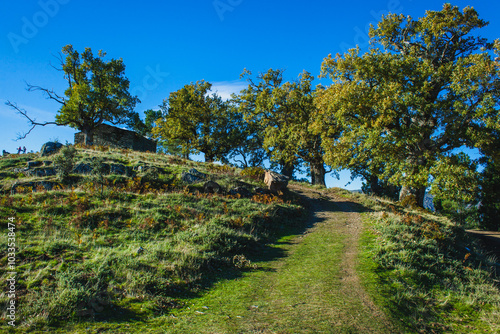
[316,4,499,205]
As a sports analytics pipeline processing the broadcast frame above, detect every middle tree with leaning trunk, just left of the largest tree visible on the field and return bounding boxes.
[236,69,326,185]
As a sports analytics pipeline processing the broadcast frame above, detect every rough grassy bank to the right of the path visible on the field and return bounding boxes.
[358,203,500,333]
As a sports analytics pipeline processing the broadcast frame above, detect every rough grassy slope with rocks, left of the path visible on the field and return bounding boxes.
[0,148,303,330]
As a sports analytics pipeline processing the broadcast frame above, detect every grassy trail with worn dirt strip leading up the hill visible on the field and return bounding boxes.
[167,185,398,333]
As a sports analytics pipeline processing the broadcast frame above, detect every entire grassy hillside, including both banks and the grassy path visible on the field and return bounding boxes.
[0,147,500,333]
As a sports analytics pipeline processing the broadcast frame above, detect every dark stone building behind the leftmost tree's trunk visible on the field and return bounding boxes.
[75,124,156,153]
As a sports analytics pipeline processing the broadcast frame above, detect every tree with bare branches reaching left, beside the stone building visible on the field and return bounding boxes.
[7,45,139,145]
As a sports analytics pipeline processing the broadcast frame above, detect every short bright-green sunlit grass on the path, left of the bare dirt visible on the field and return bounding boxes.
[58,194,390,333]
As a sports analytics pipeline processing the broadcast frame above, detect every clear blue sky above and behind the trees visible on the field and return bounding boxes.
[0,0,500,189]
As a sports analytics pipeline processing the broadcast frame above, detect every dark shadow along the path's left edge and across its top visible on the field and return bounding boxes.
[50,187,376,325]
